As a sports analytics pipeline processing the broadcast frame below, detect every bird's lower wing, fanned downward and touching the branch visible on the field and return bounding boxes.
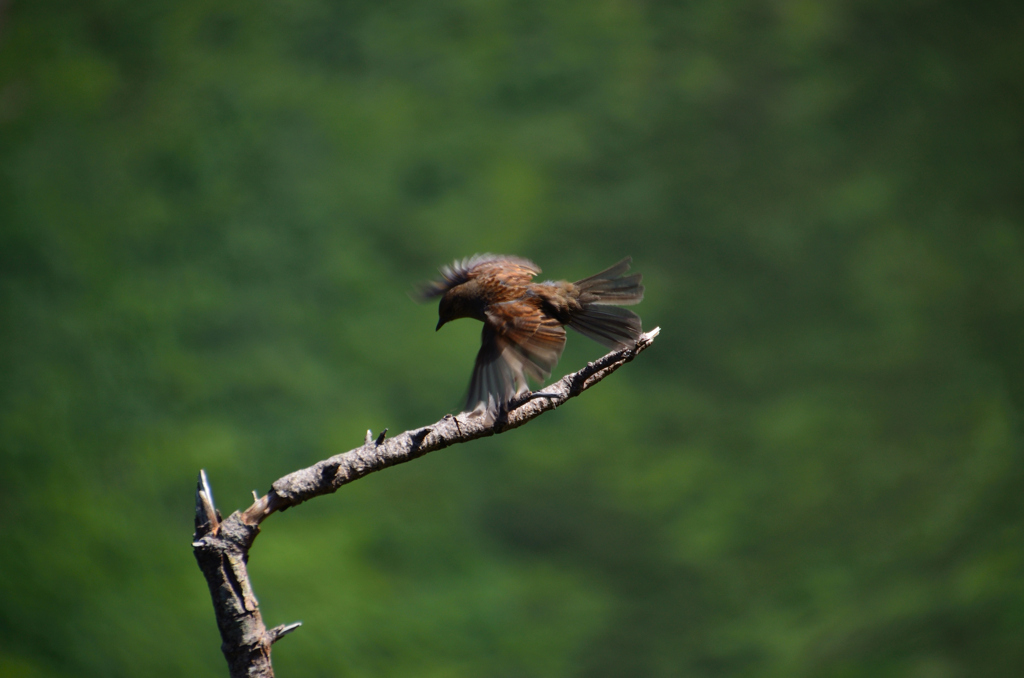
[466,297,565,413]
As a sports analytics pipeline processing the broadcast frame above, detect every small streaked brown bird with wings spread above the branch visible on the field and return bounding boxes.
[420,254,643,417]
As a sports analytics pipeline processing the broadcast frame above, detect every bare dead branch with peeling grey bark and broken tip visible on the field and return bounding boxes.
[193,328,659,678]
